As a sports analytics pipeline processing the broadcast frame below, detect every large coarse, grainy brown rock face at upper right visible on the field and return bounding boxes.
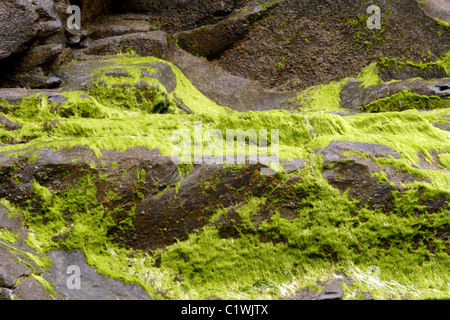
[213,0,450,90]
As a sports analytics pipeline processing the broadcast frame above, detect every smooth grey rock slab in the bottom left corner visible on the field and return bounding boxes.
[0,200,150,300]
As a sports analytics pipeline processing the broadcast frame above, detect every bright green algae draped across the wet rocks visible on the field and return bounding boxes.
[0,57,450,299]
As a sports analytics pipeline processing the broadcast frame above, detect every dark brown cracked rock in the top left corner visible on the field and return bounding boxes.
[0,0,68,88]
